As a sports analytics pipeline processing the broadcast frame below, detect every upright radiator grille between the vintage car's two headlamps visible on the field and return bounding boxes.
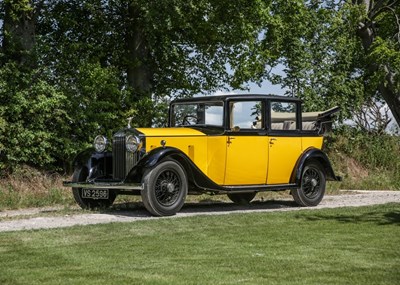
[113,135,138,180]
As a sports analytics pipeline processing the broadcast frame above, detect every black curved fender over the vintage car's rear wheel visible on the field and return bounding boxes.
[290,148,342,185]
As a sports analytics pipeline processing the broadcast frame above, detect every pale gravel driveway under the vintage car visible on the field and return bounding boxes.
[0,191,400,232]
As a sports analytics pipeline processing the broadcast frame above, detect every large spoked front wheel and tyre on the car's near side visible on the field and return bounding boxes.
[142,160,188,216]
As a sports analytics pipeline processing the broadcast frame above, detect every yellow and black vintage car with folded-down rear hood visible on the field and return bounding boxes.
[64,95,340,216]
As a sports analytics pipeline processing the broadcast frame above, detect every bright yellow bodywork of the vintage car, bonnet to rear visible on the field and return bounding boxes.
[137,128,323,186]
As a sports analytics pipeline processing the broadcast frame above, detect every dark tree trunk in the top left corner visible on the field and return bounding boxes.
[2,0,36,68]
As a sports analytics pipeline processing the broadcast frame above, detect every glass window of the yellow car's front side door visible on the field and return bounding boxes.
[229,101,264,131]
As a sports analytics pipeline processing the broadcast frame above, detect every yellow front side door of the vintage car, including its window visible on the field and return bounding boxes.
[224,101,268,185]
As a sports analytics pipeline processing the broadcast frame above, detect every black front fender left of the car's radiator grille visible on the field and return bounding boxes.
[73,148,112,179]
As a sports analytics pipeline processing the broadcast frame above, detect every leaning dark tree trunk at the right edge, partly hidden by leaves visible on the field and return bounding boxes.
[353,0,400,126]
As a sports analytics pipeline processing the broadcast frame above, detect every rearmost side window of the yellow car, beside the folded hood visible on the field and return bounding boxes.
[270,101,298,131]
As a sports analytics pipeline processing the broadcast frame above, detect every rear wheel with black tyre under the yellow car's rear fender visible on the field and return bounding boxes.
[292,161,326,207]
